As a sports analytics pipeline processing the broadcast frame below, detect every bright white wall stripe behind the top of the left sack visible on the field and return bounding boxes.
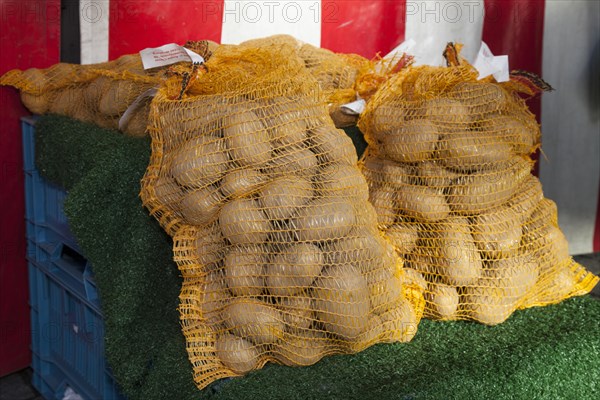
[221,0,321,46]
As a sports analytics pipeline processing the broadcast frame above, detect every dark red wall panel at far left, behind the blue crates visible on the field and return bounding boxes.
[0,0,60,376]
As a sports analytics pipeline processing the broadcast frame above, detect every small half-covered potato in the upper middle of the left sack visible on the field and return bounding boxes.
[264,147,318,178]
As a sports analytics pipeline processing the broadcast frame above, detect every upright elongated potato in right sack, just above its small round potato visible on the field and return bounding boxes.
[415,217,482,286]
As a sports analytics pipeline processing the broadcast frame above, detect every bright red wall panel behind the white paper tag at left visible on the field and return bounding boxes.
[108,0,223,60]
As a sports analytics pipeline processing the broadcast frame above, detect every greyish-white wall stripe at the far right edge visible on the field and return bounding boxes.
[540,1,600,254]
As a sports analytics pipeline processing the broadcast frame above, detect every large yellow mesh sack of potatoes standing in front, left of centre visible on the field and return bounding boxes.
[141,43,424,388]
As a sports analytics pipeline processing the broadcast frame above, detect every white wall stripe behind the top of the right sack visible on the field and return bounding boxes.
[405,0,484,65]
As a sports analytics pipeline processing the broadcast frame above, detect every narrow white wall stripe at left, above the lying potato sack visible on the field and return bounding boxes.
[79,0,109,64]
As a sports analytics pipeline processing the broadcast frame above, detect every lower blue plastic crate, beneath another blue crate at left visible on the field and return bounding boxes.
[29,260,124,400]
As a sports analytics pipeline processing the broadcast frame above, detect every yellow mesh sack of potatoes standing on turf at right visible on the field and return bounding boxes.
[359,65,598,325]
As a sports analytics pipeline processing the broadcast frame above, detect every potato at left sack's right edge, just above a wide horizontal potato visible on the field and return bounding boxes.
[317,164,369,202]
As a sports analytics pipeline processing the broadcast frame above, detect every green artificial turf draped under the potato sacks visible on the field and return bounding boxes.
[36,116,600,400]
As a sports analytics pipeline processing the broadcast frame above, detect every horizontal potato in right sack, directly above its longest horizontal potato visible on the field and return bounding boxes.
[436,131,512,172]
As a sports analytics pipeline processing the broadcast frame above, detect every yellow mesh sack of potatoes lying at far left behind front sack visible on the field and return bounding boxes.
[0,42,216,136]
